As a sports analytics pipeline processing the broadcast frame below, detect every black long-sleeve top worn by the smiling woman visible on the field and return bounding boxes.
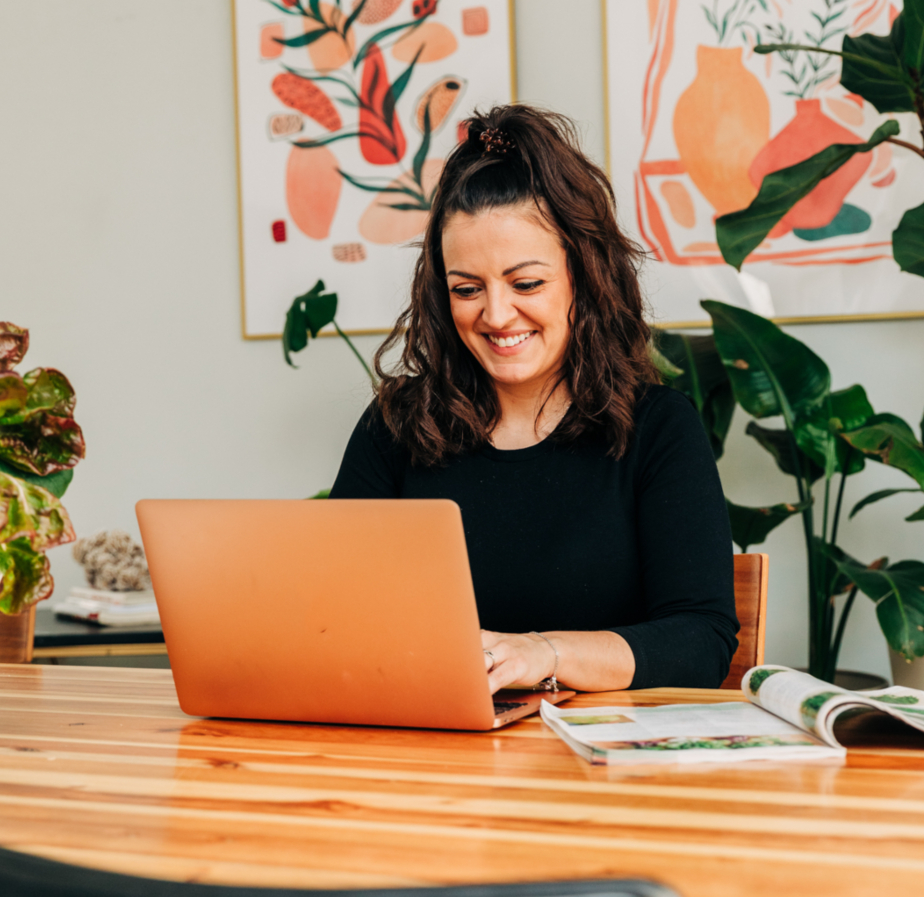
[331,386,738,688]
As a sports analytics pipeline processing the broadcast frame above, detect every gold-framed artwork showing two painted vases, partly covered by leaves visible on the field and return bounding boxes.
[602,0,924,326]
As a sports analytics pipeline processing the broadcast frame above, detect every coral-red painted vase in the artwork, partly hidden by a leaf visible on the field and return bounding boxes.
[750,100,872,238]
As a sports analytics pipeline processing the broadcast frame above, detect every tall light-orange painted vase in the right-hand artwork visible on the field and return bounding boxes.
[673,46,770,215]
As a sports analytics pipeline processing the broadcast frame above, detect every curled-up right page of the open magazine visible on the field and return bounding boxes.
[741,665,924,747]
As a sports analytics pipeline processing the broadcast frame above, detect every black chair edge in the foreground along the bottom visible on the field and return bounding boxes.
[0,848,678,897]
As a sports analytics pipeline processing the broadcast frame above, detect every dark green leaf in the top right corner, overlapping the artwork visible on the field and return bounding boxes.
[841,15,914,112]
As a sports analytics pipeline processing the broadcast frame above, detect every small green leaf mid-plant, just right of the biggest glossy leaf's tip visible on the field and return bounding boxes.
[795,385,874,477]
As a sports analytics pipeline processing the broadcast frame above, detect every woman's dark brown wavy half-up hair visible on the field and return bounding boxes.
[375,105,658,465]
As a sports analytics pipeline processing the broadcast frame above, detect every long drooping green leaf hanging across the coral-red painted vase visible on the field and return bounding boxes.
[715,121,900,271]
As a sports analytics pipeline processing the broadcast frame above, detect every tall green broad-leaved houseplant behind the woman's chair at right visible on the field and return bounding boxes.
[659,300,924,681]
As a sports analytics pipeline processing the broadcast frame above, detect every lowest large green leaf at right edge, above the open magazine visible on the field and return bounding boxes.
[834,544,924,660]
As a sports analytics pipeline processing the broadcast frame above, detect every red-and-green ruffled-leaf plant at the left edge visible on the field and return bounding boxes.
[0,323,85,663]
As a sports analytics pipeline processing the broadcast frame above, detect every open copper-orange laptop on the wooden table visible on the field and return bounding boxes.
[136,499,574,730]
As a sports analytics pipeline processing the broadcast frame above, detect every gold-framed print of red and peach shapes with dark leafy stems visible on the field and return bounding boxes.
[233,0,514,339]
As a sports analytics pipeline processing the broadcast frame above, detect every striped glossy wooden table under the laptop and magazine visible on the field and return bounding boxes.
[0,665,924,897]
